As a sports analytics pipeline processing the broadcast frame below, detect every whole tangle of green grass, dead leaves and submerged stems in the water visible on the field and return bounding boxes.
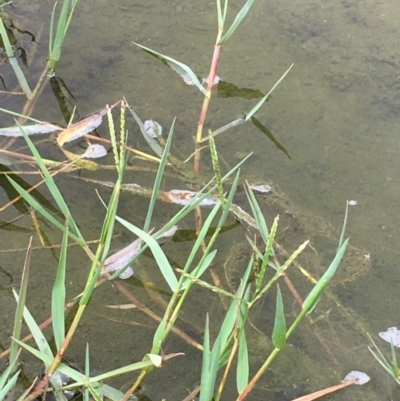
[0,0,399,401]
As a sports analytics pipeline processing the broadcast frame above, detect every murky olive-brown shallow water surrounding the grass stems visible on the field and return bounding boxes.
[0,0,400,400]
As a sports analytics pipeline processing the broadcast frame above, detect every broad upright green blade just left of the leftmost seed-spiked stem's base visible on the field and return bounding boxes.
[51,219,68,350]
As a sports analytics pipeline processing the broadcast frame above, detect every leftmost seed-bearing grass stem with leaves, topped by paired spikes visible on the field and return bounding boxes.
[5,104,130,399]
